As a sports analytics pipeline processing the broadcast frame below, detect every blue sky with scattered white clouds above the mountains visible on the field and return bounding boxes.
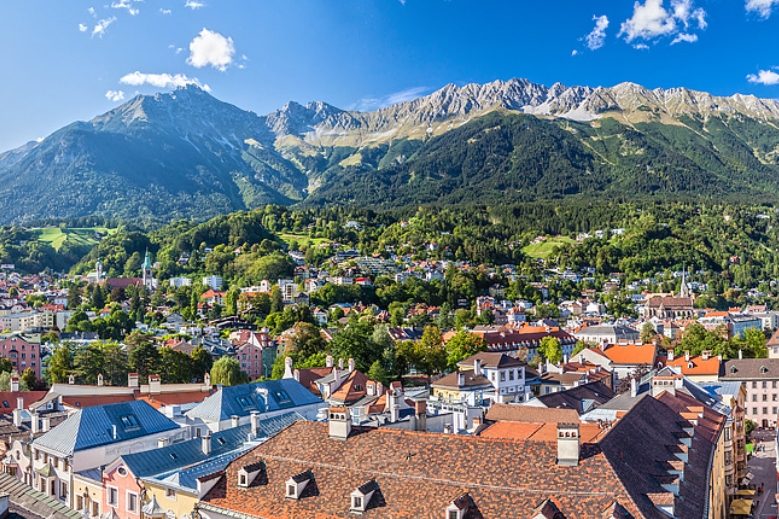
[0,0,779,151]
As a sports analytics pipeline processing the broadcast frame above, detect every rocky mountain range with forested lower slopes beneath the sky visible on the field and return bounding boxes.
[0,79,779,223]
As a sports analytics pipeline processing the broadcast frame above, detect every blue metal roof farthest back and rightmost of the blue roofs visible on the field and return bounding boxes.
[187,379,323,421]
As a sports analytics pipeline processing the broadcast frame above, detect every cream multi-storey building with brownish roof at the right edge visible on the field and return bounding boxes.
[720,359,779,427]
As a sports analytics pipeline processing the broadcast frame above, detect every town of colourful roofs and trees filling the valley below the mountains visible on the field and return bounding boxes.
[0,212,779,519]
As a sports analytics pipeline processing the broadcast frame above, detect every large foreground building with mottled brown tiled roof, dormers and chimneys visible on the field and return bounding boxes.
[197,397,724,519]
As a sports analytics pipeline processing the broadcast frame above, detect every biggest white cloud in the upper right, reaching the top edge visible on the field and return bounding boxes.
[618,0,708,44]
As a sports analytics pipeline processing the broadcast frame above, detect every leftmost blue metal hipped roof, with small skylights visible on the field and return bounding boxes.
[33,401,179,455]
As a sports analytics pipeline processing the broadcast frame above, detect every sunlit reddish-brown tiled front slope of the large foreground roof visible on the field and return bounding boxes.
[198,422,644,519]
